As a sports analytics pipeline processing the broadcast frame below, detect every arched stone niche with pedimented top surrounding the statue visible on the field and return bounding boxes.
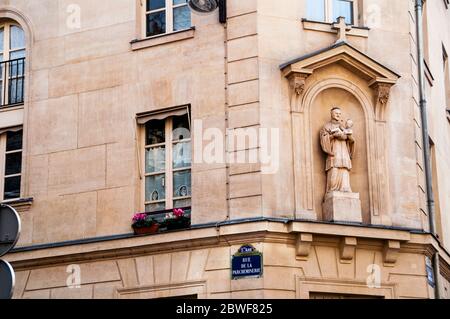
[281,43,399,225]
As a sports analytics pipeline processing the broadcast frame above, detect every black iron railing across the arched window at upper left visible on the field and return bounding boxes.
[0,58,25,108]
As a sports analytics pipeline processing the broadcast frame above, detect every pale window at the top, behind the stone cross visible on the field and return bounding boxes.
[306,0,358,24]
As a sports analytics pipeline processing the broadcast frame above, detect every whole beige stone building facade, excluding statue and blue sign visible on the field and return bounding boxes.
[0,0,450,298]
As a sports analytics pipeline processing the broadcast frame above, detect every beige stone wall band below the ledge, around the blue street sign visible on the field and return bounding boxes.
[14,237,431,299]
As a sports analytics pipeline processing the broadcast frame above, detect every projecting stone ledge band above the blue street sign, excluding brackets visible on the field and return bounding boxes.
[5,219,433,269]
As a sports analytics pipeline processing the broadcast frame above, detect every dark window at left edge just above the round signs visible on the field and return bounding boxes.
[0,130,23,200]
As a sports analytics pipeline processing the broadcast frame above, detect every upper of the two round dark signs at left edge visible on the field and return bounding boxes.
[0,205,21,257]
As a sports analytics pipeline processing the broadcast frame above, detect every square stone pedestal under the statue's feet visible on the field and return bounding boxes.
[322,192,362,223]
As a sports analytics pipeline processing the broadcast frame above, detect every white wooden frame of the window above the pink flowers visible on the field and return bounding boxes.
[140,115,192,212]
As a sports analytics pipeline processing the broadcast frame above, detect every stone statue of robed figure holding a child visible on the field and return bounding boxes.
[320,107,355,194]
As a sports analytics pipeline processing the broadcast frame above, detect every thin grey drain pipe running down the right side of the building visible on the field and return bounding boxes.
[415,0,440,299]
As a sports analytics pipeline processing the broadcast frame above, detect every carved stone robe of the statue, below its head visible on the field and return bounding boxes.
[320,122,355,193]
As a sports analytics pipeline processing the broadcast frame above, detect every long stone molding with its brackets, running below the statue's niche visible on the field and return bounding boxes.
[5,221,450,282]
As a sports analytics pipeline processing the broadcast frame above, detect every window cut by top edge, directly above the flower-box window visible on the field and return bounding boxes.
[145,0,191,37]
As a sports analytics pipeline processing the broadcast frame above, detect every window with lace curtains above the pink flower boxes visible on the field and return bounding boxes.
[144,114,192,212]
